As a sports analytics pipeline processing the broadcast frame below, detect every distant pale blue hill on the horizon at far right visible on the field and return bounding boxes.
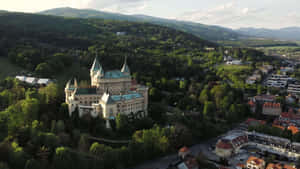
[237,27,300,41]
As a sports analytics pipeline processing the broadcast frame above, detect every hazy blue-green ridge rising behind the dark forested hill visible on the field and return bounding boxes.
[40,8,240,41]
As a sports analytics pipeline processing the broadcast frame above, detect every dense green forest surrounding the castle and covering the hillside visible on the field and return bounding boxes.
[0,12,272,169]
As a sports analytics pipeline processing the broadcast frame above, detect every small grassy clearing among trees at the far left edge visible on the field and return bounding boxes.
[0,57,22,79]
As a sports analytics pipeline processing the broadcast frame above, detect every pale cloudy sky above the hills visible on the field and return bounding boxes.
[0,0,300,29]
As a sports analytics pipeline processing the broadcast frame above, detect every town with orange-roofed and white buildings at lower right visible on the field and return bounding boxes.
[133,51,300,169]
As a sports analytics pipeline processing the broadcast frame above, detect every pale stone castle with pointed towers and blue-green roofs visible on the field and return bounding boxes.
[65,57,148,127]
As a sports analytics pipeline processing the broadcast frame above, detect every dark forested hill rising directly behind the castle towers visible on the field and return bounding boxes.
[0,13,217,79]
